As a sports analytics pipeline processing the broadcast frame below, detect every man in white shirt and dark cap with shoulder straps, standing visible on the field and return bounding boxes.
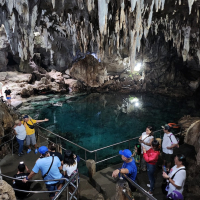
[162,124,178,170]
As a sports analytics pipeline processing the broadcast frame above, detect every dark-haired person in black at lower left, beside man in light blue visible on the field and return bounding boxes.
[13,162,31,199]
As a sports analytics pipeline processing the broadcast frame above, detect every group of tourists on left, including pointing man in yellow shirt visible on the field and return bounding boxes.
[13,115,80,199]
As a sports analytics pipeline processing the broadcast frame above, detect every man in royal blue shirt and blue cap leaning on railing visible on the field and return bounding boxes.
[112,149,137,191]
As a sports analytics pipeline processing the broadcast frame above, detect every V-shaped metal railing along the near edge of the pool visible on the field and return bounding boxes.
[36,125,163,164]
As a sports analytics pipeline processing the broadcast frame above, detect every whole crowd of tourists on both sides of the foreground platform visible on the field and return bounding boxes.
[13,109,186,200]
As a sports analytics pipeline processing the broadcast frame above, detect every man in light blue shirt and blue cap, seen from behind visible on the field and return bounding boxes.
[23,146,64,199]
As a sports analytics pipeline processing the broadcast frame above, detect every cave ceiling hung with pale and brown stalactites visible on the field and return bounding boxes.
[0,0,200,72]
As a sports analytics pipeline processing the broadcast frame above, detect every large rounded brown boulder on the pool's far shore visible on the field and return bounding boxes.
[70,55,107,87]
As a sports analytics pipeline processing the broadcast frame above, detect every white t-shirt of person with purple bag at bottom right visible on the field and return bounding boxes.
[168,165,186,194]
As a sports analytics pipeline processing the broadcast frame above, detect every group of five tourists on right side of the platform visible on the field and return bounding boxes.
[112,124,186,200]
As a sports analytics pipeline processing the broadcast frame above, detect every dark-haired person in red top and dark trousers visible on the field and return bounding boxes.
[143,140,160,195]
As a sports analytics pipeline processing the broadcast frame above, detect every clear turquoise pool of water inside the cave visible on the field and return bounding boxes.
[20,93,200,173]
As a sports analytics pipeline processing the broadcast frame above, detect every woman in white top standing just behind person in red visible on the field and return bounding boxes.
[139,126,154,171]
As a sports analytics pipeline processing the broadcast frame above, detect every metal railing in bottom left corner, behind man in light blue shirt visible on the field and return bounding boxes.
[0,168,79,200]
